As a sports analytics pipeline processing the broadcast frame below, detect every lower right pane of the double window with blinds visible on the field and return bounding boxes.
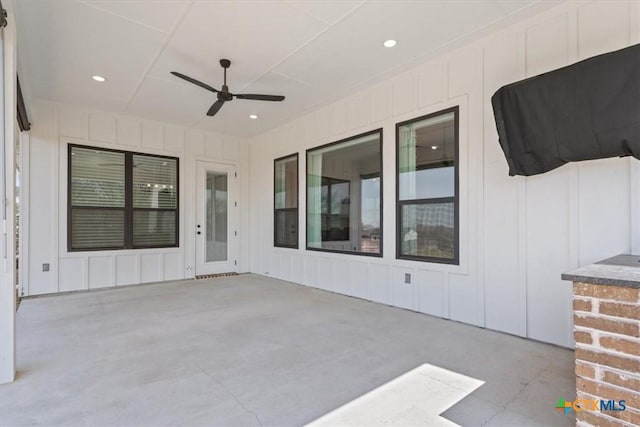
[133,211,176,247]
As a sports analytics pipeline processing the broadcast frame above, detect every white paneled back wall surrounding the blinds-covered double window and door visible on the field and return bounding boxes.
[23,100,249,295]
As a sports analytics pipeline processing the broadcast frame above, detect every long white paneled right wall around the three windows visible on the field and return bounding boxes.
[249,0,640,346]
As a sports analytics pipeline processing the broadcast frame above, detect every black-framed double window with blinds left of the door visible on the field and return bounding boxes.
[67,145,178,251]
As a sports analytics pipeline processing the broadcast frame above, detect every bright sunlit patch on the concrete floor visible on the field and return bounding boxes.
[308,363,484,427]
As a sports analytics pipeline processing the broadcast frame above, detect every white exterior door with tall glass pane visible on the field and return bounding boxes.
[194,162,238,276]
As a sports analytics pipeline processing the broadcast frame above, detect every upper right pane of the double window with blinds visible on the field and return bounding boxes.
[133,154,178,209]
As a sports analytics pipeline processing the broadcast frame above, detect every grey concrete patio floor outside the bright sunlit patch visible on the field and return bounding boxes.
[0,275,575,426]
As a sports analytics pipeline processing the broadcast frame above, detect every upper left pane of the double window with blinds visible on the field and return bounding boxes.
[70,147,124,207]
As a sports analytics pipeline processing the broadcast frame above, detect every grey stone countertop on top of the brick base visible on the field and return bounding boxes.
[562,255,640,288]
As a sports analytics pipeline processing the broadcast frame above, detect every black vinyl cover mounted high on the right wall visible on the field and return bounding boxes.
[491,44,640,176]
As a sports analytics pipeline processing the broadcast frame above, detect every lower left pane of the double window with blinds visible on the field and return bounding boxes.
[71,209,124,249]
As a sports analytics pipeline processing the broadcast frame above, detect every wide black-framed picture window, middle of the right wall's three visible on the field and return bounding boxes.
[306,129,382,256]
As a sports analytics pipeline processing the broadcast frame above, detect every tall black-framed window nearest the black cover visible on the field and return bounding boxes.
[396,107,459,264]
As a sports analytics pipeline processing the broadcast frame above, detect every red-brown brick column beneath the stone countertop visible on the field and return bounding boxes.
[573,282,640,427]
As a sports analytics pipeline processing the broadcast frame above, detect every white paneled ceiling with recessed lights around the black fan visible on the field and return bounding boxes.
[15,0,557,136]
